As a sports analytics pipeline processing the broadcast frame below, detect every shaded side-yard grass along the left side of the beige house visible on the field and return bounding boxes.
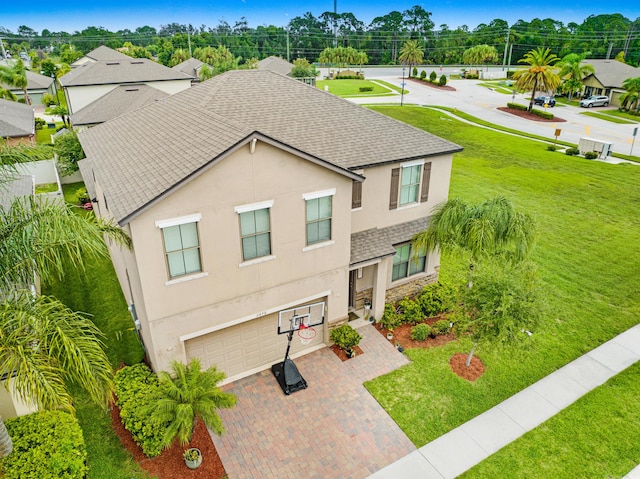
[43,183,148,479]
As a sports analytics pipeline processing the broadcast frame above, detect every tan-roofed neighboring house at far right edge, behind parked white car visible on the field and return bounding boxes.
[582,59,640,106]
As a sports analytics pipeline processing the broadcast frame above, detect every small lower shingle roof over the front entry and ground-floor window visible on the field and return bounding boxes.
[351,217,429,266]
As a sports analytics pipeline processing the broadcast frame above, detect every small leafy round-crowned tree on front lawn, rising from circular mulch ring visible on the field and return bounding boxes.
[455,260,543,366]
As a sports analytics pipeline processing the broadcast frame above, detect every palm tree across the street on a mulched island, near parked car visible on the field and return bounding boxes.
[513,47,561,111]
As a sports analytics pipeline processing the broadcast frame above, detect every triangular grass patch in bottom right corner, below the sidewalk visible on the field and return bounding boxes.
[460,363,640,479]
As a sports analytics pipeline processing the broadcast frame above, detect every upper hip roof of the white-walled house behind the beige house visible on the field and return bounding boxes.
[60,57,191,86]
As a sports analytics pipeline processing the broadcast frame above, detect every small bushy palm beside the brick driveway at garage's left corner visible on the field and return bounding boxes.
[149,358,236,447]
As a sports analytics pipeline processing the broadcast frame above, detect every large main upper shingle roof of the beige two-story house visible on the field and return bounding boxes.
[79,70,462,227]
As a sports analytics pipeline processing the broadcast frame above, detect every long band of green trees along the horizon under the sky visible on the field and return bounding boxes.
[0,9,640,65]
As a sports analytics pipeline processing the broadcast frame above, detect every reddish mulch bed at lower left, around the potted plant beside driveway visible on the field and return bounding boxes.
[111,404,227,479]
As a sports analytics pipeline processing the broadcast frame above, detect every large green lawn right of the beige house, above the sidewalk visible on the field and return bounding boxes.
[366,106,640,464]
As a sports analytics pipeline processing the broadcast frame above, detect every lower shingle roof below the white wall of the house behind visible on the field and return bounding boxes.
[71,84,167,126]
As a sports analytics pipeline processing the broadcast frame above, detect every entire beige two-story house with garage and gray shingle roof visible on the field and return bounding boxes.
[79,70,462,381]
